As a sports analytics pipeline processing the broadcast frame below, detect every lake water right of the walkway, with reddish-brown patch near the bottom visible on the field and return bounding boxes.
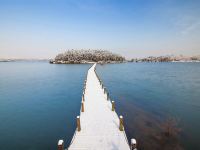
[97,63,200,150]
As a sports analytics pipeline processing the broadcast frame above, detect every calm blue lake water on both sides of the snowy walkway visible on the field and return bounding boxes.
[0,62,200,150]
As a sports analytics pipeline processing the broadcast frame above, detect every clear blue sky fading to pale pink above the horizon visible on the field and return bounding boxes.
[0,0,200,58]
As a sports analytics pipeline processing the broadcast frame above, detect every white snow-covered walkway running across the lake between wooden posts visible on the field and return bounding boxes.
[68,64,130,150]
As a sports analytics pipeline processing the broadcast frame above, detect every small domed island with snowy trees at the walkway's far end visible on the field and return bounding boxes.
[49,50,125,64]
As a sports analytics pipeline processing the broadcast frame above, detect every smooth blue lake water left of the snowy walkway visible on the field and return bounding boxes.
[0,62,90,150]
